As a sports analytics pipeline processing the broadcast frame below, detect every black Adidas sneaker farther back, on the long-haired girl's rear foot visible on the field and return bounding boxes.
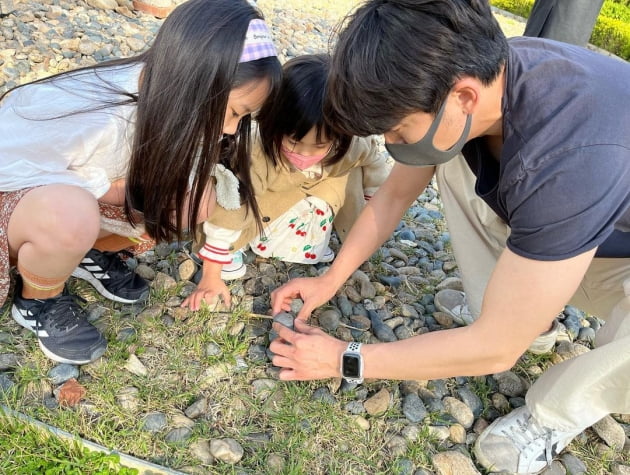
[72,249,149,303]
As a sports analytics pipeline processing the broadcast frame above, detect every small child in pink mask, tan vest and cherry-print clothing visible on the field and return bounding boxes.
[182,55,389,310]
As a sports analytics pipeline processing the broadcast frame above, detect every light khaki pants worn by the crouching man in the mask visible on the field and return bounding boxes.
[436,156,630,431]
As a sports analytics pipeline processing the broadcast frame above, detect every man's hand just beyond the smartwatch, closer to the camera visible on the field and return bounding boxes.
[269,320,347,381]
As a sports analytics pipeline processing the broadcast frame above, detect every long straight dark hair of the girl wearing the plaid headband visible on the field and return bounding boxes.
[0,0,282,241]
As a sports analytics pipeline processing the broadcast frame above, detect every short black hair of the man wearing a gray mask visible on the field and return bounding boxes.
[326,0,508,136]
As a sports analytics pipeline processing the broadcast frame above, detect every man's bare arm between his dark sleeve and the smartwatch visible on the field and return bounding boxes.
[362,249,595,379]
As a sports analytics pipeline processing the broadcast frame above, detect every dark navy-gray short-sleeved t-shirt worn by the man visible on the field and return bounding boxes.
[463,38,630,260]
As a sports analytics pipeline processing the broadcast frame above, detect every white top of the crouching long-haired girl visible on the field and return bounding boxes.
[0,64,142,198]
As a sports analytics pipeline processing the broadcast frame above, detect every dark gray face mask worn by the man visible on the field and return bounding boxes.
[385,101,472,167]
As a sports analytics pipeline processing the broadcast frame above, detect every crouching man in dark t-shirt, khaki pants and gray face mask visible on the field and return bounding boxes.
[271,0,630,473]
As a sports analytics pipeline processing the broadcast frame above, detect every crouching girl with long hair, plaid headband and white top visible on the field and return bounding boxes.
[0,0,281,364]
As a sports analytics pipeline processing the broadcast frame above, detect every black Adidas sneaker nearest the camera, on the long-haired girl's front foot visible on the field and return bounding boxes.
[11,276,107,365]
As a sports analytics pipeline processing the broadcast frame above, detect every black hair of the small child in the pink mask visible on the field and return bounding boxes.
[256,54,352,166]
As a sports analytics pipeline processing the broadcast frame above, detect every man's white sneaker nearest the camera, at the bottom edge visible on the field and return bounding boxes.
[474,406,582,474]
